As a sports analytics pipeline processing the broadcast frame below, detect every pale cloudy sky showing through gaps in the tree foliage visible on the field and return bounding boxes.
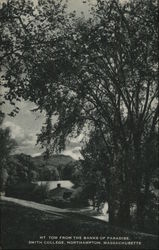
[0,0,94,159]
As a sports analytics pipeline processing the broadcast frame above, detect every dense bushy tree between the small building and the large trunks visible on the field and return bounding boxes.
[81,129,110,211]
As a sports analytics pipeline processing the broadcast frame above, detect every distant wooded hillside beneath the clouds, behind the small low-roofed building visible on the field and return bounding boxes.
[7,154,76,183]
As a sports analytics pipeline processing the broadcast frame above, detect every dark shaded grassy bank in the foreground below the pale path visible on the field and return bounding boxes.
[0,201,158,250]
